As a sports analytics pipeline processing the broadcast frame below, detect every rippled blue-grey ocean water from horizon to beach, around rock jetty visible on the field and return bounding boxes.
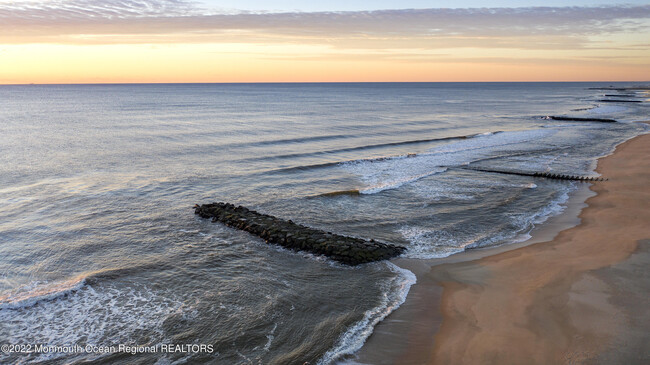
[0,83,648,364]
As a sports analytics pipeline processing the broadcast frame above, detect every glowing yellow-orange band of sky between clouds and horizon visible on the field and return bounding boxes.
[0,43,650,84]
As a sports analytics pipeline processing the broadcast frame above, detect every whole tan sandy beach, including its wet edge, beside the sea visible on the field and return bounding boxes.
[356,135,650,364]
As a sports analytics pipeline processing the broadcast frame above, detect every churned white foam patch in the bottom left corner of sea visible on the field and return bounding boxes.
[0,284,187,361]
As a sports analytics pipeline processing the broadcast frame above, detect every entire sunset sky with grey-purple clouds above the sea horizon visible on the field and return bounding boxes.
[0,0,650,84]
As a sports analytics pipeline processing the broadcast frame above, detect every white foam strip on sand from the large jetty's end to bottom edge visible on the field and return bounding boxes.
[318,262,417,365]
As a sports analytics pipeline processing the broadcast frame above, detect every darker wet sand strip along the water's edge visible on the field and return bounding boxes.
[350,176,595,365]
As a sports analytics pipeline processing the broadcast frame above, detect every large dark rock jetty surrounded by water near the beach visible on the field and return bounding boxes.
[194,203,405,265]
